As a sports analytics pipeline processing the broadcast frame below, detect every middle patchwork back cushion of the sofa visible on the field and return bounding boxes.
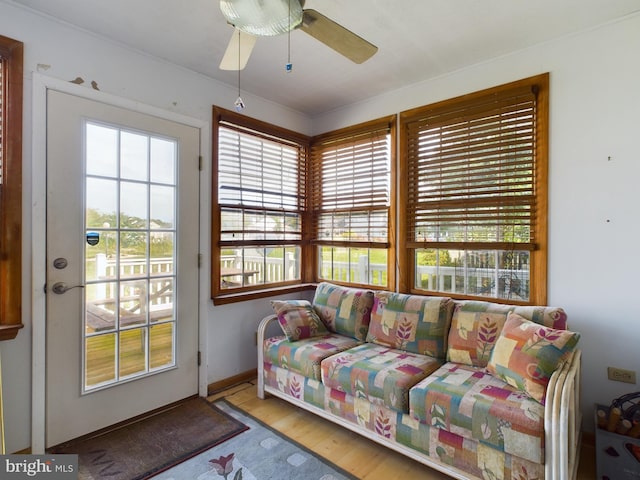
[367,292,453,360]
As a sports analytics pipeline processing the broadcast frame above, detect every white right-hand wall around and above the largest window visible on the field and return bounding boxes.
[314,15,640,430]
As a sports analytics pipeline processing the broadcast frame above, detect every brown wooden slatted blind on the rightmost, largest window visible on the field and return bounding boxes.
[407,87,536,249]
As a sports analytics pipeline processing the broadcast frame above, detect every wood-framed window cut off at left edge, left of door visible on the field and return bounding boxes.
[0,35,23,340]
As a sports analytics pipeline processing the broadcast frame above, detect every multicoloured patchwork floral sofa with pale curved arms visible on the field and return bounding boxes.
[258,283,581,480]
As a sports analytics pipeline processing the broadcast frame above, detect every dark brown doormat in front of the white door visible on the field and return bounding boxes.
[48,398,248,480]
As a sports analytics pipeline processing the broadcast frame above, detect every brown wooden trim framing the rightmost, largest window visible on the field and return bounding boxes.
[398,73,549,305]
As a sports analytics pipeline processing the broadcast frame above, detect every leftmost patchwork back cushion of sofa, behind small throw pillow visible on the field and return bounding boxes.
[312,282,373,340]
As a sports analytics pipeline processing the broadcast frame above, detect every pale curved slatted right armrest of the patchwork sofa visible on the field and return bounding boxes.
[544,350,582,480]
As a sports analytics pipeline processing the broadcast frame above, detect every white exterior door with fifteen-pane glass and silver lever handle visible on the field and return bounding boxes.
[46,90,200,447]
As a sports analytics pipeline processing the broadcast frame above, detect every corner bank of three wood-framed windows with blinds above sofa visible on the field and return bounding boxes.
[212,74,549,304]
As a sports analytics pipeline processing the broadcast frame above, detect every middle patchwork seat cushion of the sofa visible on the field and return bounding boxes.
[321,343,442,413]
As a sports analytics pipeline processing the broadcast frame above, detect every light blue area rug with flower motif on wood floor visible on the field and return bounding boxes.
[153,400,357,480]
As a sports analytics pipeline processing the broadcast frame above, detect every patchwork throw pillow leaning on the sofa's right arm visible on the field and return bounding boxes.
[487,313,580,405]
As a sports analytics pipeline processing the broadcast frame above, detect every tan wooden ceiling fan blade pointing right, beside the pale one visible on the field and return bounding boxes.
[299,9,378,63]
